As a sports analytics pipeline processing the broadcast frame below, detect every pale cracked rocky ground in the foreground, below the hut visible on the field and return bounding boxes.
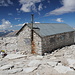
[0,45,75,75]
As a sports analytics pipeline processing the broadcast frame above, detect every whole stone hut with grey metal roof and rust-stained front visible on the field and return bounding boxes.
[16,23,74,55]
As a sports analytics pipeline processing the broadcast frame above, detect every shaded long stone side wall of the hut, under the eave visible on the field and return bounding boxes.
[42,32,74,53]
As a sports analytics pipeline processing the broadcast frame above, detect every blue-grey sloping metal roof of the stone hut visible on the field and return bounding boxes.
[28,23,74,37]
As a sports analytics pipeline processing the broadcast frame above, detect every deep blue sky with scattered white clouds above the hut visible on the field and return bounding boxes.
[0,0,75,30]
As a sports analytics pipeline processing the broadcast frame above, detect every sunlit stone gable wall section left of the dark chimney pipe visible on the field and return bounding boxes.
[17,26,31,54]
